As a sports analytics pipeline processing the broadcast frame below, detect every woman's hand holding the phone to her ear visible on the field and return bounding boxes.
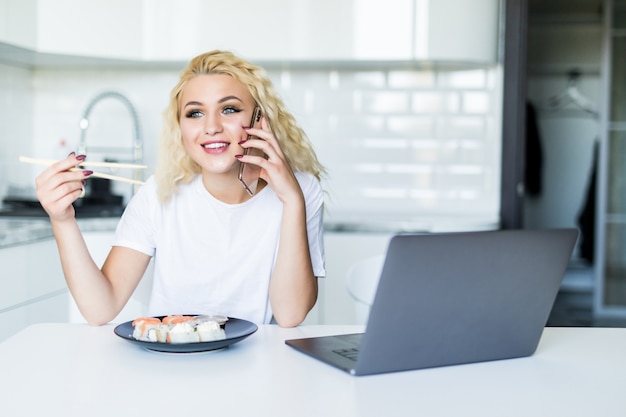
[239,117,303,204]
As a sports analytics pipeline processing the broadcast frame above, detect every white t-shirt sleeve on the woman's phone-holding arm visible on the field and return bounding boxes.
[298,174,326,278]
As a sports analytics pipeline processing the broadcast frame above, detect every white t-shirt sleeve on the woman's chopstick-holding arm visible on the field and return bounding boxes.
[113,177,158,256]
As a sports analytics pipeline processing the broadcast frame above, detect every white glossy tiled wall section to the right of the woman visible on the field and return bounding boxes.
[284,68,501,223]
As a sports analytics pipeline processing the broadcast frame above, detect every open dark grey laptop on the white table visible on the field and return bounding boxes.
[285,229,578,375]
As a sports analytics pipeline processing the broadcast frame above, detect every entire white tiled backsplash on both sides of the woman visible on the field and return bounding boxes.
[0,60,501,229]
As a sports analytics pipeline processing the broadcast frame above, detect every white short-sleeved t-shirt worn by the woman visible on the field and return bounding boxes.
[113,173,326,324]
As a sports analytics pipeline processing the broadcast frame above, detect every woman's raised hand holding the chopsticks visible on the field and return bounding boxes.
[35,152,93,221]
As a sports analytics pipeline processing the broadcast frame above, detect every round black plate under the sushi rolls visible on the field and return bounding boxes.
[113,316,258,353]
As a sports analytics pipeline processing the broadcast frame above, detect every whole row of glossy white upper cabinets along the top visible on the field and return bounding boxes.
[0,0,499,63]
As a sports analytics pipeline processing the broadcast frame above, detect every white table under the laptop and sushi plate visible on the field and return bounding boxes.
[0,324,626,417]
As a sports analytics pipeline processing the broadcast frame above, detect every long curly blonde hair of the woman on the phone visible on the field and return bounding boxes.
[155,50,324,202]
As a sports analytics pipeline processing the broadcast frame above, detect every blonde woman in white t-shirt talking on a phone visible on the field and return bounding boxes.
[36,51,325,327]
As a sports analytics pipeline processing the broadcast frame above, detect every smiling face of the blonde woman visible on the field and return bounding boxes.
[178,74,254,175]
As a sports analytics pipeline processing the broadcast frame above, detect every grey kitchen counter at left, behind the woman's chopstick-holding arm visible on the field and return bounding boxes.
[0,216,119,249]
